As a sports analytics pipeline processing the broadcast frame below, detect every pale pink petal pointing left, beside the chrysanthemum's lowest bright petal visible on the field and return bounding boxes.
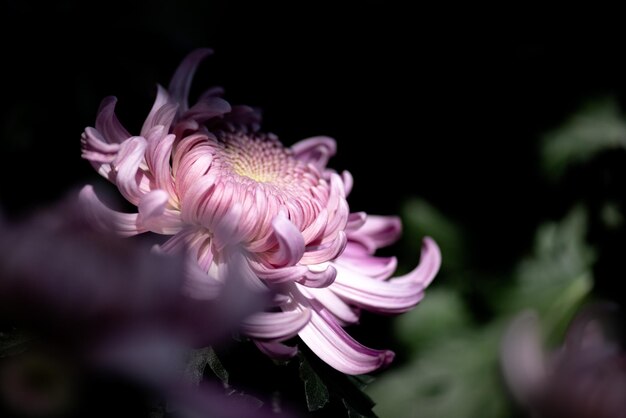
[241,309,311,341]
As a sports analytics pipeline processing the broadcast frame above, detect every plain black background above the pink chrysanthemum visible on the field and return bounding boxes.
[0,0,626,328]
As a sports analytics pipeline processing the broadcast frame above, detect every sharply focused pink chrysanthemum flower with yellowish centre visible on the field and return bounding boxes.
[82,49,441,374]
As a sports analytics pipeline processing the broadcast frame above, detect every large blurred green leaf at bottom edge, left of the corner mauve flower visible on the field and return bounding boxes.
[368,325,507,418]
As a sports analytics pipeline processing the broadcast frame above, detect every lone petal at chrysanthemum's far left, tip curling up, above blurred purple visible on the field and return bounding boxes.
[79,186,146,237]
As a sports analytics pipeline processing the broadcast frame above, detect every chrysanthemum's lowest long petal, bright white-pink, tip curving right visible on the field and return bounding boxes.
[298,304,394,375]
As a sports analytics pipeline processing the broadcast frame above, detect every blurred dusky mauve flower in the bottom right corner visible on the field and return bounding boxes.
[502,307,626,418]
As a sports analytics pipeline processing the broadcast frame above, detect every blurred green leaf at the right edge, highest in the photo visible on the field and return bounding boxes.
[542,98,626,178]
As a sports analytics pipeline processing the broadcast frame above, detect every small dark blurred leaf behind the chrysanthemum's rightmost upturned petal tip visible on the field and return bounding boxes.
[402,198,467,271]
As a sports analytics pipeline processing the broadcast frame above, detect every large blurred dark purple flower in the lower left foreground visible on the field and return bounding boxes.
[0,199,278,417]
